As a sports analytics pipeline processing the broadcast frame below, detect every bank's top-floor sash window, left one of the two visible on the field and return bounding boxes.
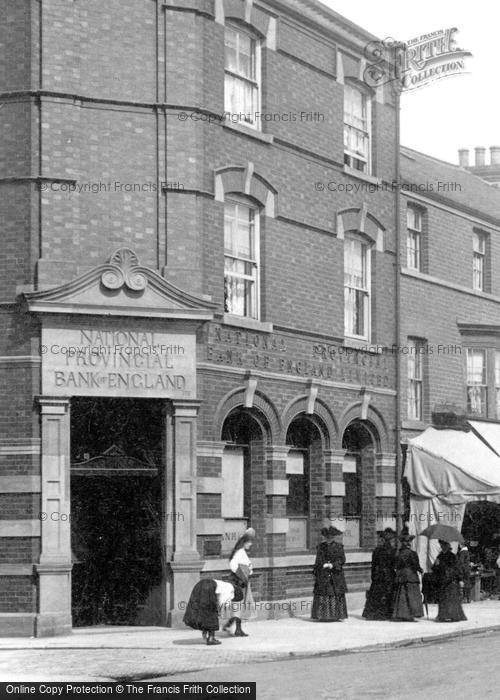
[224,26,260,127]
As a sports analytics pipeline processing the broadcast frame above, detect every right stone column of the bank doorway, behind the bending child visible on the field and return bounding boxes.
[163,400,204,627]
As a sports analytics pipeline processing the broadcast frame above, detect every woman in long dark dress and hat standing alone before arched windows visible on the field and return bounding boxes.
[311,527,347,622]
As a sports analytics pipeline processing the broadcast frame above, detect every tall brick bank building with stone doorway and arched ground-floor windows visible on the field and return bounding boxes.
[0,0,400,636]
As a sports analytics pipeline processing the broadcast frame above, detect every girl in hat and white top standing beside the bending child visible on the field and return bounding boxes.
[223,527,256,637]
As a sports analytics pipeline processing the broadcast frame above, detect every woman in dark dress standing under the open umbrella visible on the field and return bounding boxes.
[432,540,467,622]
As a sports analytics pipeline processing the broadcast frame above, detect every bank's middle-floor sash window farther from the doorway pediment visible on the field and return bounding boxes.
[344,238,370,340]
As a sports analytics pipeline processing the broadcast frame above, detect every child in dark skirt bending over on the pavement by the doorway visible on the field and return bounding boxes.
[183,578,243,646]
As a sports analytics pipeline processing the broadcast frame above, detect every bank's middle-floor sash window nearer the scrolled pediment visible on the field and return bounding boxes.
[224,201,259,319]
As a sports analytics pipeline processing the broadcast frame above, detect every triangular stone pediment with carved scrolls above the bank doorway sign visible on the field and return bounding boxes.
[24,248,216,321]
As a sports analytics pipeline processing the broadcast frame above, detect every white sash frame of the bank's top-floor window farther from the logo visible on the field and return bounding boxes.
[224,24,262,131]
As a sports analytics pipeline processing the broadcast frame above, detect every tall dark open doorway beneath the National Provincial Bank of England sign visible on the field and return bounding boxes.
[71,397,162,626]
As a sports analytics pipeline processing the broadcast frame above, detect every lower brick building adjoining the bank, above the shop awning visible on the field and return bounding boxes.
[400,148,500,438]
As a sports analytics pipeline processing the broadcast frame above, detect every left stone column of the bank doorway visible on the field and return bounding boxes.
[35,396,72,637]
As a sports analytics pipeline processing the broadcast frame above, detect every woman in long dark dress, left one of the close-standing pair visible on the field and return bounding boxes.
[363,527,396,620]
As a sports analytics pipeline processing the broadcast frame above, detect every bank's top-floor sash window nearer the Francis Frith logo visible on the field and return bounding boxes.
[344,84,371,173]
